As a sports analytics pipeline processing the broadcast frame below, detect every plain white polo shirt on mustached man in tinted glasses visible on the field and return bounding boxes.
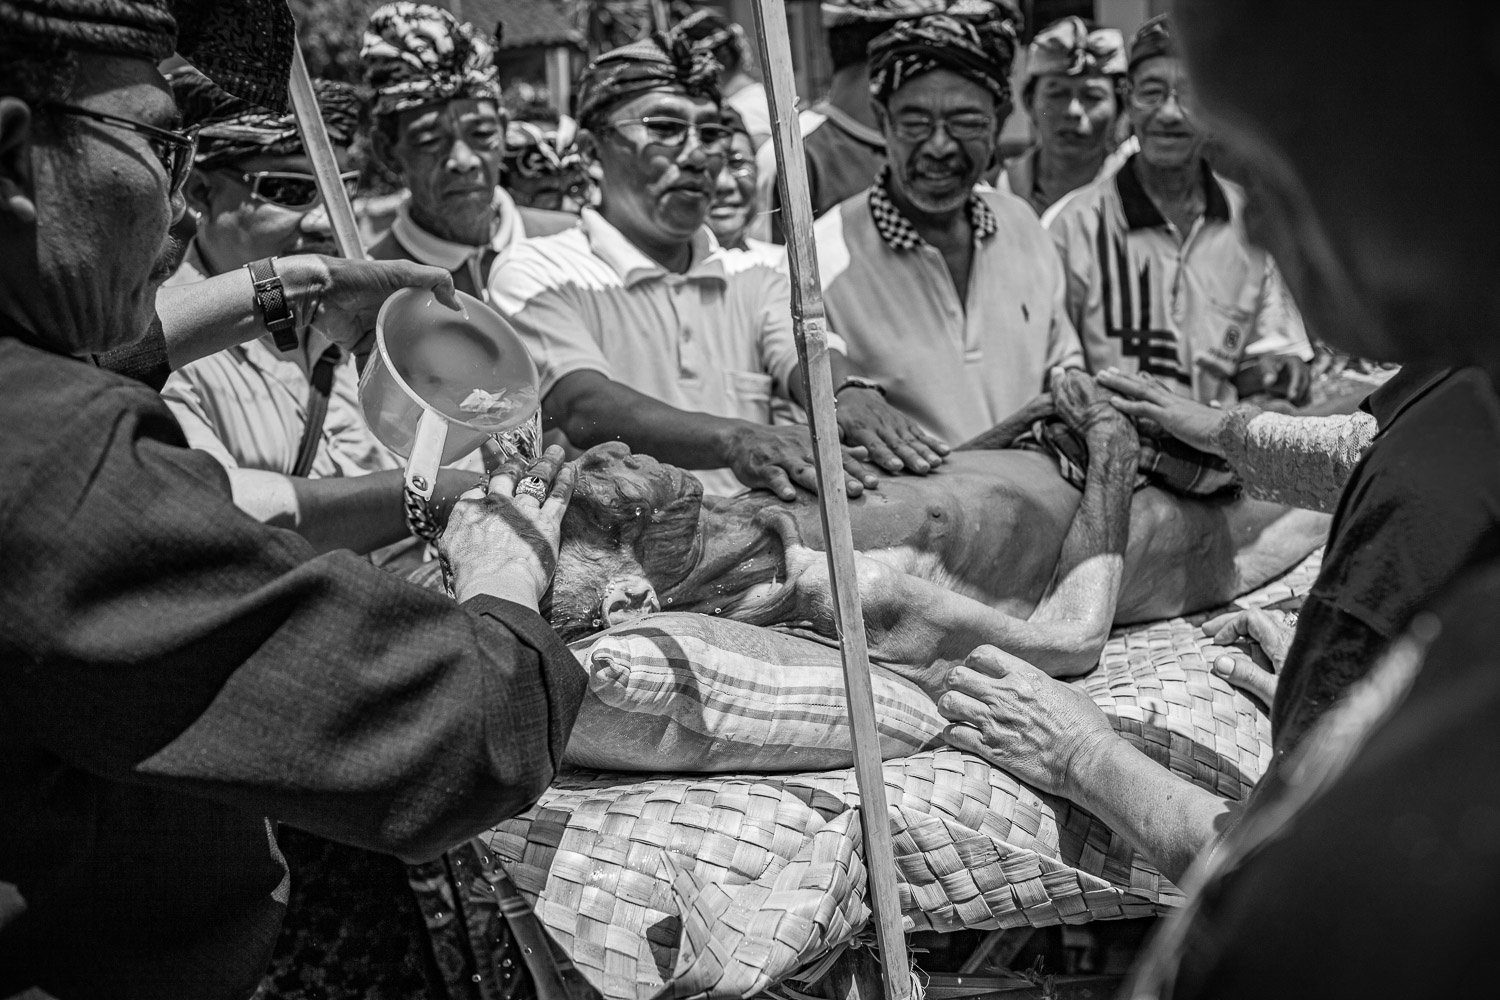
[489,208,843,495]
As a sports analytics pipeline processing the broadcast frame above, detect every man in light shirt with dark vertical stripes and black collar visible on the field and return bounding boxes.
[1050,15,1313,403]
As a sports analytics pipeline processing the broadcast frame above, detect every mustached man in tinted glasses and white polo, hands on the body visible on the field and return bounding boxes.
[491,34,942,499]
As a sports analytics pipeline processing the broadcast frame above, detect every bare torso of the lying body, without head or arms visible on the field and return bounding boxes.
[690,450,1328,624]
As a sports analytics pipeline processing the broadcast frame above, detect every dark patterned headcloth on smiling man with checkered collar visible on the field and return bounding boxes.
[870,0,1019,103]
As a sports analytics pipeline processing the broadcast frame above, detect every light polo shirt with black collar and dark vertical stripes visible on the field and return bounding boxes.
[1049,157,1313,403]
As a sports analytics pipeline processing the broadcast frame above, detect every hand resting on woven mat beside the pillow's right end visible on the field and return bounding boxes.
[938,646,1119,798]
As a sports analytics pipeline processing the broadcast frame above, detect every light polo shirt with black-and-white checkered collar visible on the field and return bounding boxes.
[815,178,1083,445]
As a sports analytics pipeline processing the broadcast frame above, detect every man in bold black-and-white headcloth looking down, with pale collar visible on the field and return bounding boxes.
[360,0,578,298]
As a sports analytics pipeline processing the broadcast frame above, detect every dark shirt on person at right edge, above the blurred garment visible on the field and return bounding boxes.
[1271,367,1500,759]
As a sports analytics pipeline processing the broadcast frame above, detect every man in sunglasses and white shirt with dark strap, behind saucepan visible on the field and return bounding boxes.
[162,69,474,562]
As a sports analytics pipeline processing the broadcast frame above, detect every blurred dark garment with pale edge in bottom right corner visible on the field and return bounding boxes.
[1131,561,1500,1000]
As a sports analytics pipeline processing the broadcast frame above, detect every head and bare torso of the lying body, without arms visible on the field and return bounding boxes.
[543,442,1328,640]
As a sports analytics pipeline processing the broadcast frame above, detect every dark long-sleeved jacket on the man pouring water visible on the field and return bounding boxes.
[0,337,584,1000]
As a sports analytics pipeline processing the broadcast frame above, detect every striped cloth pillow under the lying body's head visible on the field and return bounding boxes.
[563,613,947,774]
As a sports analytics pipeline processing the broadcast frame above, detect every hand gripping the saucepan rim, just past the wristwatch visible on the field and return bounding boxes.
[276,253,459,354]
